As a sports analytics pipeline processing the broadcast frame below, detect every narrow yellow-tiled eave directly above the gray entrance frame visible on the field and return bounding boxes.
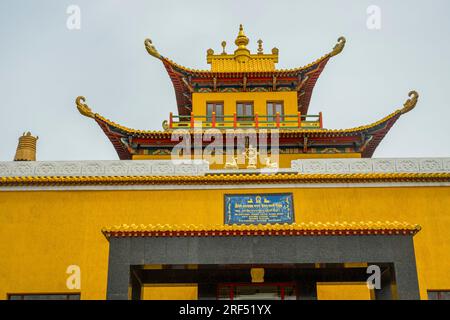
[102,221,421,238]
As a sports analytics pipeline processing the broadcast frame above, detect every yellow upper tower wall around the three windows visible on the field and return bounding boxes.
[192,91,298,116]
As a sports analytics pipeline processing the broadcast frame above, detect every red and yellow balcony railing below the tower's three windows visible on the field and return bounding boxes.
[168,112,322,129]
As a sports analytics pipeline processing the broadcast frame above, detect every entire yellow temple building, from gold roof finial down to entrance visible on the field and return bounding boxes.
[0,25,450,300]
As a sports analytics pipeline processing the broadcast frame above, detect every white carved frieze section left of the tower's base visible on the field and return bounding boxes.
[0,160,209,177]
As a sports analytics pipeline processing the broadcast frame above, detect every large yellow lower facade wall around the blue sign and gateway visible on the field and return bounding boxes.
[0,187,450,299]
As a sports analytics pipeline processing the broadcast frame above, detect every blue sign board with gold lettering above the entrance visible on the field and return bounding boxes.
[225,193,294,224]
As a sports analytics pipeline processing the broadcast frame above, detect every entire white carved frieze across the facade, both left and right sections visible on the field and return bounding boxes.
[0,158,450,177]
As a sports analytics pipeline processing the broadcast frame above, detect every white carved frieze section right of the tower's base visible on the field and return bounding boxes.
[291,158,450,174]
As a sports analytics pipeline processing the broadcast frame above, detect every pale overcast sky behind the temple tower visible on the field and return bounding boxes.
[0,0,450,161]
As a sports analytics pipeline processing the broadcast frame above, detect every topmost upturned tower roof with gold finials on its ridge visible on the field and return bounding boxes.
[145,25,345,115]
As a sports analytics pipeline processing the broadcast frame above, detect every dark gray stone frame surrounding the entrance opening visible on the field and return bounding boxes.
[107,235,419,299]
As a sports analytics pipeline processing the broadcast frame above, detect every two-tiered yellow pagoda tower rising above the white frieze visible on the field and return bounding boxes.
[77,25,418,169]
